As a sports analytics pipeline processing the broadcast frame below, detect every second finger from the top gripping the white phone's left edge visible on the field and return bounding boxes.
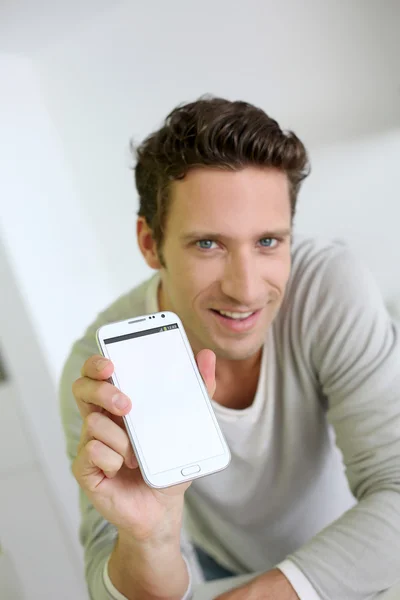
[72,377,132,418]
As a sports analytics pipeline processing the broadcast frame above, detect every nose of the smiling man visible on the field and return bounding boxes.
[221,252,264,309]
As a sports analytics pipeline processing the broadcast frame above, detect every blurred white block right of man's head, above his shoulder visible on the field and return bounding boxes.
[296,129,400,302]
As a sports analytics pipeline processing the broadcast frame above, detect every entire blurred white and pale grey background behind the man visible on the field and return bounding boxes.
[0,0,400,600]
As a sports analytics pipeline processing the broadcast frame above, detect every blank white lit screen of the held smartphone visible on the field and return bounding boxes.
[104,323,224,475]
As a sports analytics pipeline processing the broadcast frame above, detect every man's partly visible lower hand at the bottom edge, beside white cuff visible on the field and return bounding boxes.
[215,569,299,600]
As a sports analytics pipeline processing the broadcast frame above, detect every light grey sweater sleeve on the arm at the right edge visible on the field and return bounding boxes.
[288,241,400,600]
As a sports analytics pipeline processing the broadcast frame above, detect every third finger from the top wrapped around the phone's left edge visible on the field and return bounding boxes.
[80,412,138,468]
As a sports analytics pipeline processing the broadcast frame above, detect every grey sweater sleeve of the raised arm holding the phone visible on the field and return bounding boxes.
[60,324,202,600]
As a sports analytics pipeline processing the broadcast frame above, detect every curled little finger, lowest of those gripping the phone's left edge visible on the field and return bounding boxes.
[72,440,124,492]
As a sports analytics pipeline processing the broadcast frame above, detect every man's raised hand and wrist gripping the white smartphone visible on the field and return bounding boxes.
[72,350,215,600]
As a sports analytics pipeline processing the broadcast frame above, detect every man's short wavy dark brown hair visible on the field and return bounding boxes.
[135,97,310,255]
